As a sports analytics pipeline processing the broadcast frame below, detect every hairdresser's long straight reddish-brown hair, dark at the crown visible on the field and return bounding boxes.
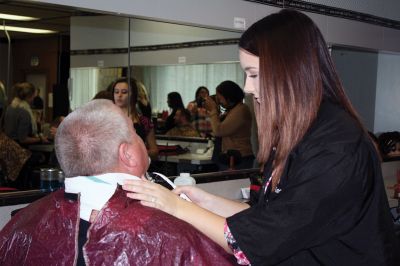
[239,9,363,188]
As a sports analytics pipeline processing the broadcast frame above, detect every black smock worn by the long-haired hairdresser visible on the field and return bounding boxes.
[227,101,400,266]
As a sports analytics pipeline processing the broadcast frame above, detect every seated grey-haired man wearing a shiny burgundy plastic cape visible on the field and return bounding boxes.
[0,100,231,265]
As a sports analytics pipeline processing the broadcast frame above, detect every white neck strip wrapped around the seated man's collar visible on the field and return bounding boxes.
[65,173,140,221]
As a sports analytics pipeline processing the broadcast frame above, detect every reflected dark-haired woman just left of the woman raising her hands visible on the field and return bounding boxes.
[187,86,212,137]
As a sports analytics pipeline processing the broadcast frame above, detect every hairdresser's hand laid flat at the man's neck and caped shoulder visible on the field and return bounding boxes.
[122,180,184,216]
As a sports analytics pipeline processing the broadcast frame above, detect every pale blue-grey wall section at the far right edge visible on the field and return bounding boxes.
[374,53,400,132]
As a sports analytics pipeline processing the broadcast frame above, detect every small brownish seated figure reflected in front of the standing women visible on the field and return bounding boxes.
[166,108,200,137]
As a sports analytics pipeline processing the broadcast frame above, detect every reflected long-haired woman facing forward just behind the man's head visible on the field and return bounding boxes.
[112,78,158,160]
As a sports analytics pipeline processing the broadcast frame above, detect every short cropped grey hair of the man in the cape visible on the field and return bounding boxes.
[55,99,133,177]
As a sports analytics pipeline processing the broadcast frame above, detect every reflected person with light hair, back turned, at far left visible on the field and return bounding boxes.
[4,82,48,145]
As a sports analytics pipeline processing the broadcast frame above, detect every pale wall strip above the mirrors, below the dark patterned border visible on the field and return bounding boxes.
[33,0,400,52]
